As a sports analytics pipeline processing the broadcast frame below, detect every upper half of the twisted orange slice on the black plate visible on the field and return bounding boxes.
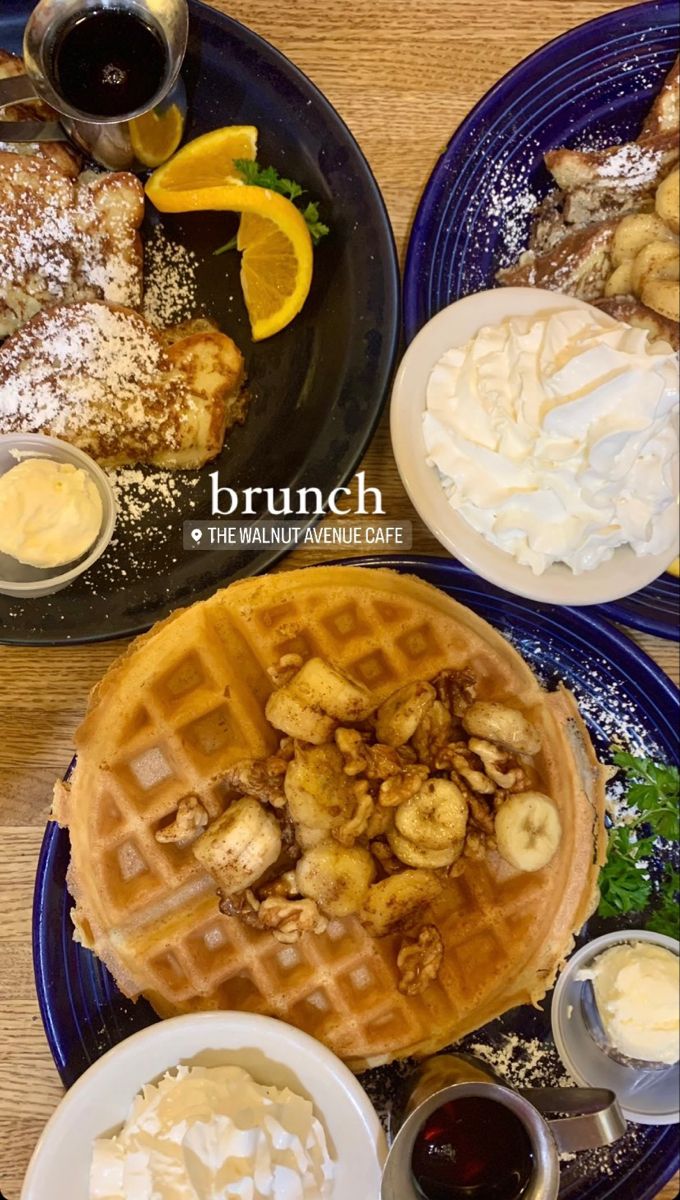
[146,125,258,190]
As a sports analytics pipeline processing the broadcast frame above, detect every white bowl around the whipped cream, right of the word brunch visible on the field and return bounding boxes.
[390,288,678,605]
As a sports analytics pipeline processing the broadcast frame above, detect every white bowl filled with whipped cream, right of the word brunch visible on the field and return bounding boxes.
[391,288,679,605]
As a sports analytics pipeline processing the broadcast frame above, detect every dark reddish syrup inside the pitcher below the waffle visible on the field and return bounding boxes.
[411,1096,534,1200]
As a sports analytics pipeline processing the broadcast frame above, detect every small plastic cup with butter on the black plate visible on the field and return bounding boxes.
[0,433,116,600]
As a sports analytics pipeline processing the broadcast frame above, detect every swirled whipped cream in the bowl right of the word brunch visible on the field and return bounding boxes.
[423,308,679,575]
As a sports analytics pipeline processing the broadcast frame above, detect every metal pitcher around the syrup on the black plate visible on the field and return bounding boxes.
[0,0,188,170]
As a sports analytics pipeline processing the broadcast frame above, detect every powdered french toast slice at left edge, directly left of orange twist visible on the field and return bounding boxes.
[0,151,144,337]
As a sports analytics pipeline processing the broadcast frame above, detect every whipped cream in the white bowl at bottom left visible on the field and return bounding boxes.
[90,1067,333,1200]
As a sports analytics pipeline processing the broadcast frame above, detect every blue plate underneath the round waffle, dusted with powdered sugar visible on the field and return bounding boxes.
[34,557,680,1200]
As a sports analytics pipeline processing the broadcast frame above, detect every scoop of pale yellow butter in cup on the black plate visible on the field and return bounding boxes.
[0,458,103,568]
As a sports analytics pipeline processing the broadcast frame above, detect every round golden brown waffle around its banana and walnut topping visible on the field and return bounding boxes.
[54,566,603,1069]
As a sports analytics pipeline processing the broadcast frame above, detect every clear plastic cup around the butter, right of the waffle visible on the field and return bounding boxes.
[552,930,680,1124]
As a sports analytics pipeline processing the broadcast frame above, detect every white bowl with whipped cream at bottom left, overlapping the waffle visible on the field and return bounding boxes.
[22,1013,386,1200]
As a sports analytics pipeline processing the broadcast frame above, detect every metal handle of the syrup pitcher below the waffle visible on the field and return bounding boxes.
[520,1087,626,1153]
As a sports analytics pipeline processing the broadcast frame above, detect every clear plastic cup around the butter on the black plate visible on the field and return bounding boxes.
[0,433,116,600]
